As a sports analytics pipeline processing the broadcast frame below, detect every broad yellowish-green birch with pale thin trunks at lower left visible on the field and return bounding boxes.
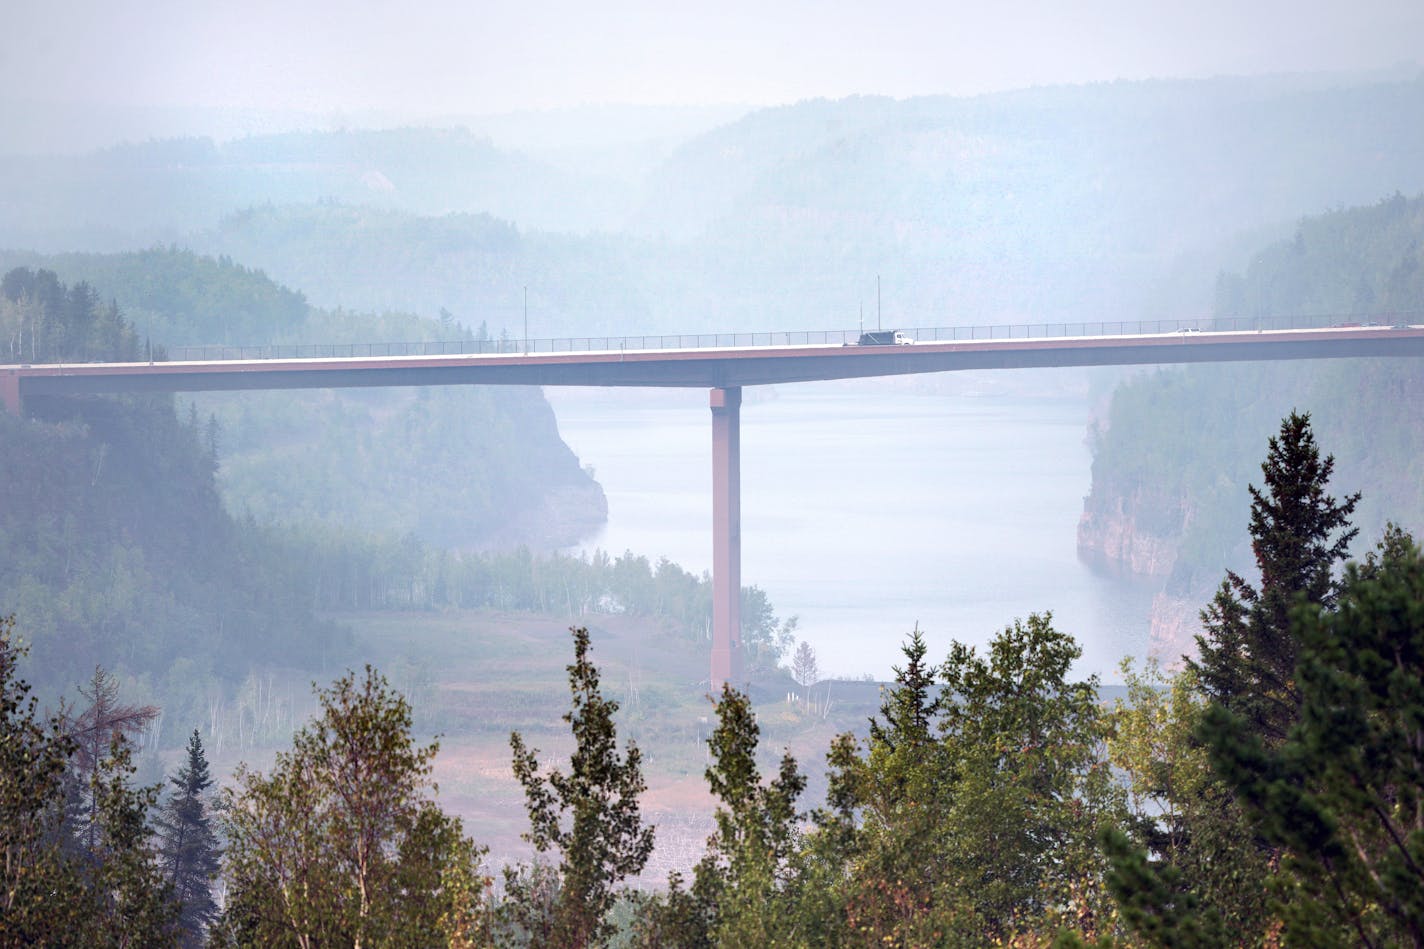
[216,667,486,946]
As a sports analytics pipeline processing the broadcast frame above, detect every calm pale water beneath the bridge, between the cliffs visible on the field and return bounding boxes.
[545,380,1152,681]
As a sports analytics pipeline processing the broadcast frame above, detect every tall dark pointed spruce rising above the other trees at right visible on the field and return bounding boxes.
[1189,412,1360,742]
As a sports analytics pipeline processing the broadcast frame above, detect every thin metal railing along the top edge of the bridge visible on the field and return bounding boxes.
[147,312,1424,362]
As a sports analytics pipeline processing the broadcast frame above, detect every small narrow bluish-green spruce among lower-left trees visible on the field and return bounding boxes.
[154,728,222,946]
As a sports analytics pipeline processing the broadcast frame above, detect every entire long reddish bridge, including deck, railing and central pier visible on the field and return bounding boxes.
[0,315,1424,691]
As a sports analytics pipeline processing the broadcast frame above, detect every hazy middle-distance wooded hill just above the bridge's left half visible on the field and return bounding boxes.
[189,202,666,338]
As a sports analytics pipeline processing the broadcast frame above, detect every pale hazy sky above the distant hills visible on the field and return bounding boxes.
[0,0,1424,115]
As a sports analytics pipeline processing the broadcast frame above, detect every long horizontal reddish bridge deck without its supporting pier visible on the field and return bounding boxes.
[0,326,1424,412]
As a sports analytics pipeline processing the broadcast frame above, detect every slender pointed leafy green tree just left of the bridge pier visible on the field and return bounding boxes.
[507,627,652,946]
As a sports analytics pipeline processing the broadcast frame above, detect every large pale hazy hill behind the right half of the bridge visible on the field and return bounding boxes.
[637,77,1424,325]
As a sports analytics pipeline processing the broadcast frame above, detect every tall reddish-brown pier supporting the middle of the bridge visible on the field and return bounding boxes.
[711,386,742,694]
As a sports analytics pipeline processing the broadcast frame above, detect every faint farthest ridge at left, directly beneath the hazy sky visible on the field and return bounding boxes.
[0,128,617,251]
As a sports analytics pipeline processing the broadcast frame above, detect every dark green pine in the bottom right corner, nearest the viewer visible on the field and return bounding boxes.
[1203,530,1424,946]
